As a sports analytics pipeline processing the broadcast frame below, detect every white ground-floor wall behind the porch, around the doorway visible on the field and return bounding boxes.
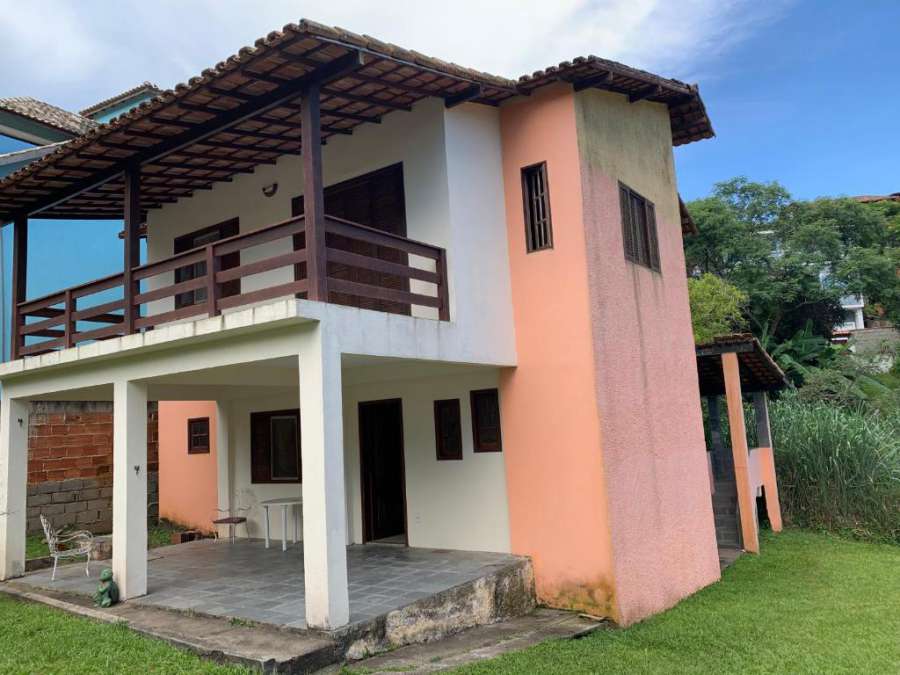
[213,368,509,552]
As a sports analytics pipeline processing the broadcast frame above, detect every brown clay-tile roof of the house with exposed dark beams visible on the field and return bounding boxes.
[0,21,712,222]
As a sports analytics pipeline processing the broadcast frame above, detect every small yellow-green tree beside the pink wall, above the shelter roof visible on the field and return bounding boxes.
[688,273,747,344]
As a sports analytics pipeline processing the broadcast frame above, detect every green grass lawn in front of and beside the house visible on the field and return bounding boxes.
[0,531,900,675]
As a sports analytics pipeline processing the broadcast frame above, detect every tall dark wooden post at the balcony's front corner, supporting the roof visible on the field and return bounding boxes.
[300,82,328,302]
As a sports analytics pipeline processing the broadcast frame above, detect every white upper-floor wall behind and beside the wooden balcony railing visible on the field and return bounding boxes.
[146,100,515,361]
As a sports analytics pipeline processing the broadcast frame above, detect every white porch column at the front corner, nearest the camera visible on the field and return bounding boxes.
[299,324,350,629]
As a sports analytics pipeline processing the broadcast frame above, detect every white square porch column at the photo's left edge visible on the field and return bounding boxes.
[0,396,30,581]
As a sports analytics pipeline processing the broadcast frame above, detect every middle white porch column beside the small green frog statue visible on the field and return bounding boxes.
[112,381,147,600]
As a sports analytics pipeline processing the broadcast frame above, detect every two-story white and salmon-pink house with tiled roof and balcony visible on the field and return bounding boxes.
[0,21,719,628]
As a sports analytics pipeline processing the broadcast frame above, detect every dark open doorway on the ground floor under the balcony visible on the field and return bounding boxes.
[359,399,406,541]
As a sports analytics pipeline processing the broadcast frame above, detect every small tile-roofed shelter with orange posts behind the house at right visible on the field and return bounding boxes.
[697,334,789,553]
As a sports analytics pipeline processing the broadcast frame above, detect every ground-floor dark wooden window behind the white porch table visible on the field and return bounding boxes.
[250,410,303,483]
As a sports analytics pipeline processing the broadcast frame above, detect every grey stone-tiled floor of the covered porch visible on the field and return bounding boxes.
[18,539,517,628]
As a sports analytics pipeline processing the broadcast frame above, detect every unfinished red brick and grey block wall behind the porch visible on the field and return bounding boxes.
[27,401,159,534]
